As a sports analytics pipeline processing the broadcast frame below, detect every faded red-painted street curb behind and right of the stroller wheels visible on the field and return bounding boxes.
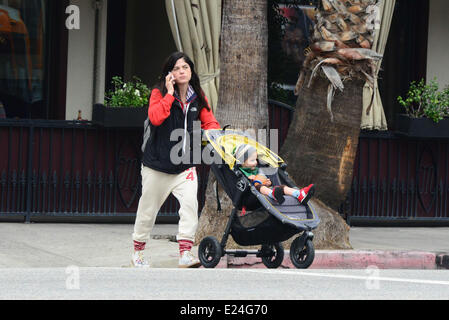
[217,250,440,270]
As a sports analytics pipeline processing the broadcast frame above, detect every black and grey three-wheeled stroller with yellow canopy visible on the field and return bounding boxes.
[198,129,320,268]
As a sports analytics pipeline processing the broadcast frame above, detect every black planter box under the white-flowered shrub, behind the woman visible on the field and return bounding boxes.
[92,103,148,128]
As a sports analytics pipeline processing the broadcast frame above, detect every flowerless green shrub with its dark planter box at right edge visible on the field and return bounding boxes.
[396,79,449,138]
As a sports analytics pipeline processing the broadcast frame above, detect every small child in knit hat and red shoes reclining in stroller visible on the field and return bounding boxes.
[233,144,315,204]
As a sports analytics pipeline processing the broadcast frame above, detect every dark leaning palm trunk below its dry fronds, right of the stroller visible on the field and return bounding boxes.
[281,77,364,249]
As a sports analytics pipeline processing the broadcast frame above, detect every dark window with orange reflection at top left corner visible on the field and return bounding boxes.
[0,0,46,118]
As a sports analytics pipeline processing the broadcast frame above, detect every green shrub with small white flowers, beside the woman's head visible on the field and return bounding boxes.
[105,76,151,107]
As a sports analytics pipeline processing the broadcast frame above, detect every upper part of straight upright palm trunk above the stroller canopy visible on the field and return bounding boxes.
[216,0,268,130]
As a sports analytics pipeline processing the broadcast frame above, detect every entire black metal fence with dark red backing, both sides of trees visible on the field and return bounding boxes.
[5,104,449,224]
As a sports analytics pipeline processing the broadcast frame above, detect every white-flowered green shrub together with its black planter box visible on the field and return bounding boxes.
[92,76,151,128]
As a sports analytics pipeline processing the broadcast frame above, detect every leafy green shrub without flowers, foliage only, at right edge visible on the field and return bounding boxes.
[397,79,449,122]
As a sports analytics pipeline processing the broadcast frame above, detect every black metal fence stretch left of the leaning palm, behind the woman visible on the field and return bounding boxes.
[0,100,293,221]
